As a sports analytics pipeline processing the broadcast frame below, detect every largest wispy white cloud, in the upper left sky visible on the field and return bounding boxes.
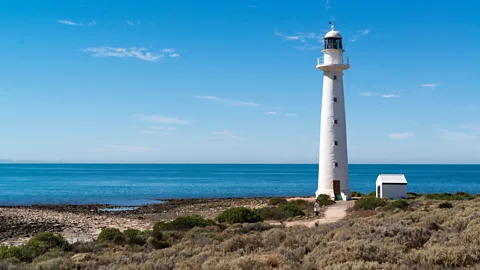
[83,46,180,62]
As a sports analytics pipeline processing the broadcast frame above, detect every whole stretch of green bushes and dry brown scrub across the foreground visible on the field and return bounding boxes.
[0,196,480,270]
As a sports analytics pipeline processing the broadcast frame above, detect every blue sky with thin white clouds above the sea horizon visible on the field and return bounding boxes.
[0,0,480,163]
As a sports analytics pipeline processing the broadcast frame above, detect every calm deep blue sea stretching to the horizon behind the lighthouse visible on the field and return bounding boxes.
[0,164,480,206]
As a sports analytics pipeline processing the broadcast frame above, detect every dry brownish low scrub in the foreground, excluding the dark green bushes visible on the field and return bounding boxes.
[0,199,480,270]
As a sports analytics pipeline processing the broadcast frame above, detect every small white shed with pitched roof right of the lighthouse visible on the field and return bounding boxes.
[375,174,407,199]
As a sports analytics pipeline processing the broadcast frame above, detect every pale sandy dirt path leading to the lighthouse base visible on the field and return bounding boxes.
[272,201,354,228]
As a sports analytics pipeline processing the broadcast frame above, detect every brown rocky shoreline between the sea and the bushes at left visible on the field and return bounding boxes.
[0,197,311,245]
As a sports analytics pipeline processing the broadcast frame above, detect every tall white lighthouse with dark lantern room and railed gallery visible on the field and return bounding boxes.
[315,25,351,200]
